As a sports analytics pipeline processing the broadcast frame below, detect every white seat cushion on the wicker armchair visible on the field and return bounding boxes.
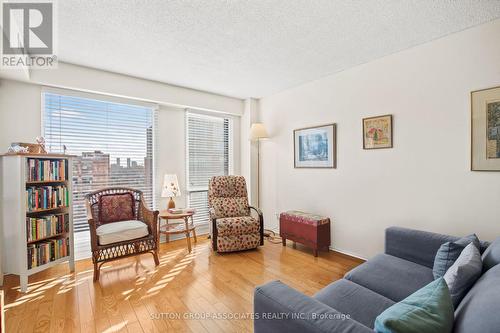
[96,220,149,245]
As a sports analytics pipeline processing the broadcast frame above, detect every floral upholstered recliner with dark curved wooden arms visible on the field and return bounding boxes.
[208,176,264,252]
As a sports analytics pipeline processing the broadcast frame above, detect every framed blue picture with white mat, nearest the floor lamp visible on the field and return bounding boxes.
[293,124,337,168]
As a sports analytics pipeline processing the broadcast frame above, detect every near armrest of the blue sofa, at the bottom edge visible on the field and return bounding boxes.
[254,281,373,333]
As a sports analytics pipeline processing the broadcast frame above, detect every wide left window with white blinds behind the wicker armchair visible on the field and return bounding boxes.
[42,92,157,231]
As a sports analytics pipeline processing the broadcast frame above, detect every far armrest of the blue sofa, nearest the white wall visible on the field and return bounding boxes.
[385,227,458,268]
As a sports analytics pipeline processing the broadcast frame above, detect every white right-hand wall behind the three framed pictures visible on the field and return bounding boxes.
[260,20,500,257]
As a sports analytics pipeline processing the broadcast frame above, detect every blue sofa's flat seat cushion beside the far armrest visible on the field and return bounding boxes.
[345,254,434,302]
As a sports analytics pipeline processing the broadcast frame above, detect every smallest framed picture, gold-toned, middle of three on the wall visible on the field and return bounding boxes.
[363,114,392,149]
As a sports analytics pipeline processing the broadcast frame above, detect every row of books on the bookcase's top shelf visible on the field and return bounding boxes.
[26,158,68,182]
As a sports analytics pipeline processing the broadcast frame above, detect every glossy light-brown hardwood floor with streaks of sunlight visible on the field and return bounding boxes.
[3,236,362,333]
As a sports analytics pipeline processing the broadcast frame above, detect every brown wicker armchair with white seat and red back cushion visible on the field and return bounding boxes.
[85,187,159,281]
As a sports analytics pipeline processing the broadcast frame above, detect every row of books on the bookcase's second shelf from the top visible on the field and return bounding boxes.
[26,185,69,212]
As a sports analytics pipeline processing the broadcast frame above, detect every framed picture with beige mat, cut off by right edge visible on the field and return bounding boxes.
[471,87,500,171]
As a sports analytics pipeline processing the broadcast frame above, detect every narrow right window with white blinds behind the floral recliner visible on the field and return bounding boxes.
[186,112,232,223]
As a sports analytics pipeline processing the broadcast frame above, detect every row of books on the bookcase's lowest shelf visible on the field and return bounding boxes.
[28,238,69,269]
